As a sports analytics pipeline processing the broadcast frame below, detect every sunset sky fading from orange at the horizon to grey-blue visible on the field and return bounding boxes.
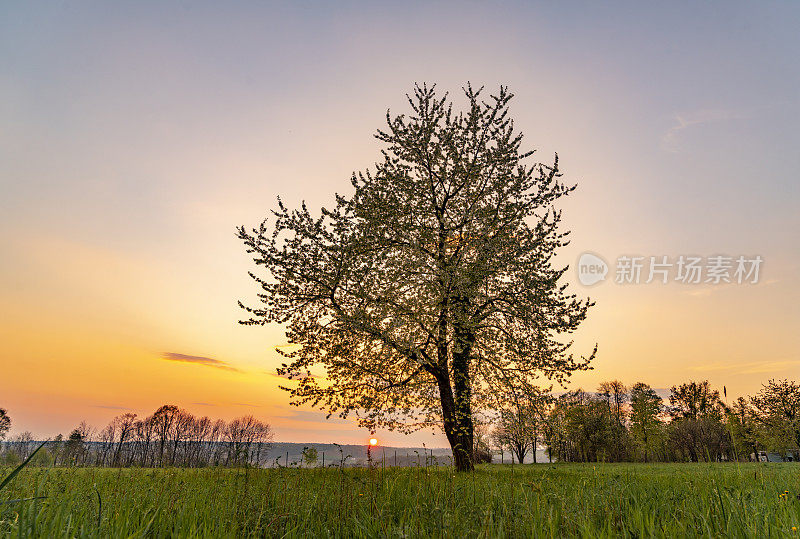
[0,2,800,446]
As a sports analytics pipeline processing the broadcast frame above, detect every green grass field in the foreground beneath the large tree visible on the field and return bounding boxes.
[0,463,800,537]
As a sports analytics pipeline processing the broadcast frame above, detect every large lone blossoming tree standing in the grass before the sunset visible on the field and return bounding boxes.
[238,85,594,471]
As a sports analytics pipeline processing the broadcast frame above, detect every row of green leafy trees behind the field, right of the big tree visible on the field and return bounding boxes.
[484,380,800,462]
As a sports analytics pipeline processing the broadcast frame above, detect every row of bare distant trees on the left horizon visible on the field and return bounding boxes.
[0,404,273,467]
